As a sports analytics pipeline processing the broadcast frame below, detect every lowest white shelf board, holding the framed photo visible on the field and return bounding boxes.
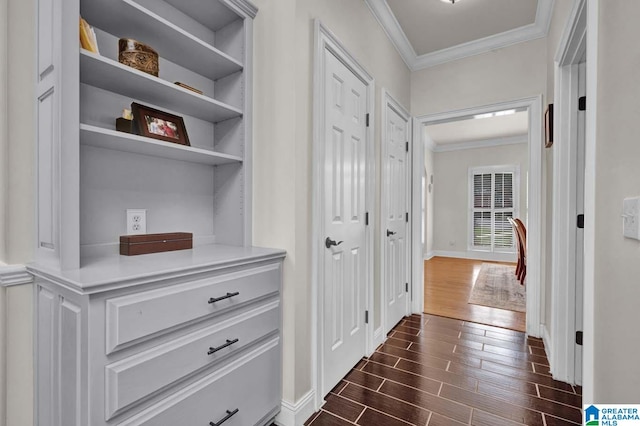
[80,124,242,166]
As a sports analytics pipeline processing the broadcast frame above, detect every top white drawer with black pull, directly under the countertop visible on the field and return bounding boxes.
[106,263,281,354]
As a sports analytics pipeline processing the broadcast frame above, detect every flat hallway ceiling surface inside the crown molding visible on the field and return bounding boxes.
[387,0,538,55]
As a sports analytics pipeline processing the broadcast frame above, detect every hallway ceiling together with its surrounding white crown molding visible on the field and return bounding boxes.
[365,0,554,71]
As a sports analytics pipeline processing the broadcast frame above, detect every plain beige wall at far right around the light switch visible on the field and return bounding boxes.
[585,0,640,403]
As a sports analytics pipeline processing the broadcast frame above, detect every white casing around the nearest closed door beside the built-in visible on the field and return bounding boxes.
[311,19,375,411]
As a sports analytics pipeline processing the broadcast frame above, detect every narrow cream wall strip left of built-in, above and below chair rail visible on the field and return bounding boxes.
[0,0,36,426]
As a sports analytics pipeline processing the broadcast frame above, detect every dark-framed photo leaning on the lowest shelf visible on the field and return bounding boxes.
[131,102,191,146]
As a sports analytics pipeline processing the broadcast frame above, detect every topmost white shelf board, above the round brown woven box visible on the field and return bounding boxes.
[81,0,242,80]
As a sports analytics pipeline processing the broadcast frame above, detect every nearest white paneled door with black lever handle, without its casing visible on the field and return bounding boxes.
[321,49,367,396]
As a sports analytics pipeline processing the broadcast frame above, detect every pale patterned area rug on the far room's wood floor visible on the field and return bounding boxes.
[469,263,526,312]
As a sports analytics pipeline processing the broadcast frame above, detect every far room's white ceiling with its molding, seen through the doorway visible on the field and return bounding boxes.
[425,111,529,151]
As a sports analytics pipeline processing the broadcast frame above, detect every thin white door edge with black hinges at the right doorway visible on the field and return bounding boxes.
[574,62,587,385]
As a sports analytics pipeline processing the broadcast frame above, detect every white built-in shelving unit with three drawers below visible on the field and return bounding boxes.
[29,0,285,426]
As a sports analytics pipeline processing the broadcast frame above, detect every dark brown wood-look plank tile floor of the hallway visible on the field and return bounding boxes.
[305,314,582,426]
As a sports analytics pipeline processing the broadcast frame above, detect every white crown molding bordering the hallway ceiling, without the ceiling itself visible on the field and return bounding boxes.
[365,0,555,71]
